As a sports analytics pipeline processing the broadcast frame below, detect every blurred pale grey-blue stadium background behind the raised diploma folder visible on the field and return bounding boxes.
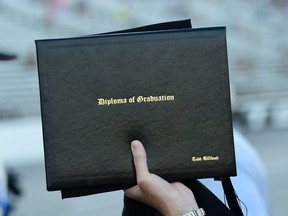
[0,0,288,216]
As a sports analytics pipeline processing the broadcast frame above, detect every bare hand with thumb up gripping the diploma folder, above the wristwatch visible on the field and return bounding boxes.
[124,140,198,216]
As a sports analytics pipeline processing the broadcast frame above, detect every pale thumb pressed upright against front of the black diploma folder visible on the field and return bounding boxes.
[131,140,149,180]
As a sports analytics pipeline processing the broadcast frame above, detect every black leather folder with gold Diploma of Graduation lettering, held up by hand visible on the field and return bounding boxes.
[36,19,236,197]
